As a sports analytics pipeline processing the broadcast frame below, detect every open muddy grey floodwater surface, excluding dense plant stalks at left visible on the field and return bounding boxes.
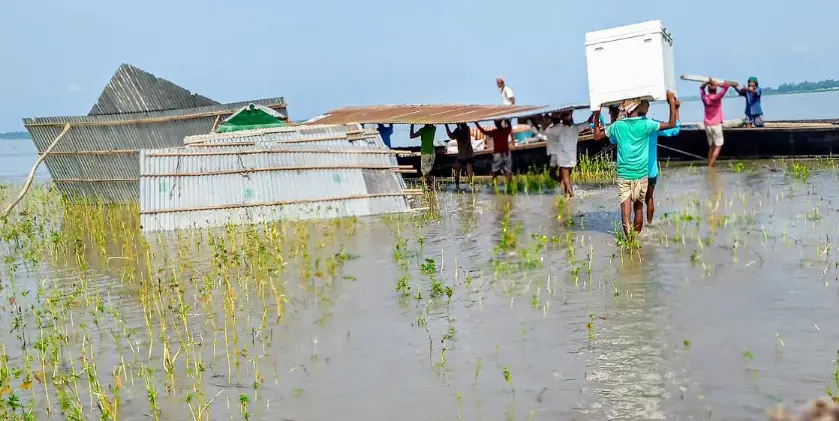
[0,168,839,420]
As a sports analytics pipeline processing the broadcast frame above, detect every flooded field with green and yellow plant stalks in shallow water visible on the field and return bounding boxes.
[0,164,839,421]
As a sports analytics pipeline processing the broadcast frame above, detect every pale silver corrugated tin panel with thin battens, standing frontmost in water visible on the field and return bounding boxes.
[140,136,416,231]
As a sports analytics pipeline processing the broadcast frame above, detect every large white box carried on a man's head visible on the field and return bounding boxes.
[586,20,676,110]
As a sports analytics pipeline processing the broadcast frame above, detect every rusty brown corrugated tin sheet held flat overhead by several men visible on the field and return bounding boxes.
[304,104,544,124]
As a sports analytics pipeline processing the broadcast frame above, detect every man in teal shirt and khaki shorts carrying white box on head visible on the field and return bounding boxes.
[594,91,678,238]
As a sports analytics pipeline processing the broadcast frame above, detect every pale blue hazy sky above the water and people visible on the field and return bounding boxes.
[0,0,839,131]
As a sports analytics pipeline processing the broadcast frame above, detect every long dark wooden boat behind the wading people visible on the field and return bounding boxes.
[395,119,839,177]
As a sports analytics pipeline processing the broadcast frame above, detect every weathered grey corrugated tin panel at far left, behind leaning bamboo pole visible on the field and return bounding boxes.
[24,98,285,203]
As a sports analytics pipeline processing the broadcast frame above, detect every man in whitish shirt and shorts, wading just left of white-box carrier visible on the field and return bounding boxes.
[545,110,593,199]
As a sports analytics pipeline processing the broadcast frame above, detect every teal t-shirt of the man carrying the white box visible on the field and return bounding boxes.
[606,117,661,180]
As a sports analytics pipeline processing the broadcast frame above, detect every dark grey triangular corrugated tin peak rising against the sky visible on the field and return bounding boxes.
[89,64,219,115]
